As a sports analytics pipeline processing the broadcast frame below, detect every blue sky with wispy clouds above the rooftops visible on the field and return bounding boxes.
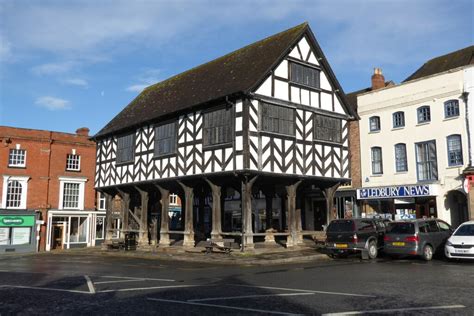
[0,0,474,134]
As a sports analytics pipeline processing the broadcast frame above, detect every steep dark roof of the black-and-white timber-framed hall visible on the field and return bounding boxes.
[93,22,357,139]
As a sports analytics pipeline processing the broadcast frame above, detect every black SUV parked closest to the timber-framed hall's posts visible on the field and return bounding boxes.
[326,218,385,259]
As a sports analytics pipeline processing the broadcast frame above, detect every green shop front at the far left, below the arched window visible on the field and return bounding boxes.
[0,210,37,253]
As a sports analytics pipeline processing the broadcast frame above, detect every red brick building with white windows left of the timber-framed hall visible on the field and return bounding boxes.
[0,126,105,251]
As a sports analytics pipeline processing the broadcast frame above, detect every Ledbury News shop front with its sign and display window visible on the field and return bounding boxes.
[357,184,439,220]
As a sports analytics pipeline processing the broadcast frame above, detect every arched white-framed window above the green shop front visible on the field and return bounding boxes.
[1,175,29,209]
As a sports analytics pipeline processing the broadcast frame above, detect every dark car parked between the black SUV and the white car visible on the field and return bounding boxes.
[384,218,453,261]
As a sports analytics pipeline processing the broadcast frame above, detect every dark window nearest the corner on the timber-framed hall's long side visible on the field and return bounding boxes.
[203,108,233,146]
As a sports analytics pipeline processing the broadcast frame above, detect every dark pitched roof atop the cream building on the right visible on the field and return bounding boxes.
[403,45,474,82]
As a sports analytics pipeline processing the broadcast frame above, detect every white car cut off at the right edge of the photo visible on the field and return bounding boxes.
[444,221,474,259]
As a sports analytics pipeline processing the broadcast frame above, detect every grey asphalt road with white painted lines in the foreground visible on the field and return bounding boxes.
[0,254,474,315]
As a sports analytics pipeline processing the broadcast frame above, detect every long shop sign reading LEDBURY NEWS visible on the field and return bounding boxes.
[357,184,437,200]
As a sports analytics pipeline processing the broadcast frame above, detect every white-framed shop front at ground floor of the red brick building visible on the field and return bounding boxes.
[46,210,105,251]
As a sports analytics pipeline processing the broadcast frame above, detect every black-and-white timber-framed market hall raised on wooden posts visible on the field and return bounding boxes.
[94,23,357,249]
